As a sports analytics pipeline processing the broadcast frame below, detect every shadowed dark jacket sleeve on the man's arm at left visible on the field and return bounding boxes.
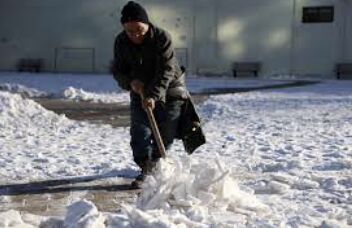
[112,37,131,90]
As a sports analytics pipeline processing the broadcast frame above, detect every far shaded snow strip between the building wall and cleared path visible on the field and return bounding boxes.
[0,72,294,103]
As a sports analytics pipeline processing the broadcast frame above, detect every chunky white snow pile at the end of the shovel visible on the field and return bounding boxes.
[114,157,270,227]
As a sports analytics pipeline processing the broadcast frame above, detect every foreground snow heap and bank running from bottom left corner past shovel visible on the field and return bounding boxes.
[0,157,271,228]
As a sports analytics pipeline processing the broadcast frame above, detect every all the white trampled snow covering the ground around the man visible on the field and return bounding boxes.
[0,74,352,227]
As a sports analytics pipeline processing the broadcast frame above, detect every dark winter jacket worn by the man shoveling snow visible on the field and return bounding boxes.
[112,24,186,101]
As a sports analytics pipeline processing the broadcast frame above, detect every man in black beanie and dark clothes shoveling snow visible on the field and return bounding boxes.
[112,1,205,186]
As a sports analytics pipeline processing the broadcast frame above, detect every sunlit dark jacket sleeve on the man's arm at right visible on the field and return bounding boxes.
[146,32,175,100]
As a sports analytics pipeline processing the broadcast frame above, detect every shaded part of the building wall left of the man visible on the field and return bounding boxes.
[0,0,120,72]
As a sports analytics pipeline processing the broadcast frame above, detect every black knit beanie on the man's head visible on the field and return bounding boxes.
[121,1,149,24]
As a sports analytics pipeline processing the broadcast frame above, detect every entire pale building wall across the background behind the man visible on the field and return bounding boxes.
[0,0,352,77]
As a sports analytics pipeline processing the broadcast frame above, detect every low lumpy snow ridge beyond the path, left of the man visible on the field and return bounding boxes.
[61,87,130,103]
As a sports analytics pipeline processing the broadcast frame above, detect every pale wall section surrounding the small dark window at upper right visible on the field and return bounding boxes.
[292,0,344,77]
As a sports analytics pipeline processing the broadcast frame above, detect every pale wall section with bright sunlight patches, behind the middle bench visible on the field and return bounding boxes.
[217,0,293,74]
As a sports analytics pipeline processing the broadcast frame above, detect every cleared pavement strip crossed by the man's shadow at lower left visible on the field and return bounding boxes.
[0,177,140,216]
